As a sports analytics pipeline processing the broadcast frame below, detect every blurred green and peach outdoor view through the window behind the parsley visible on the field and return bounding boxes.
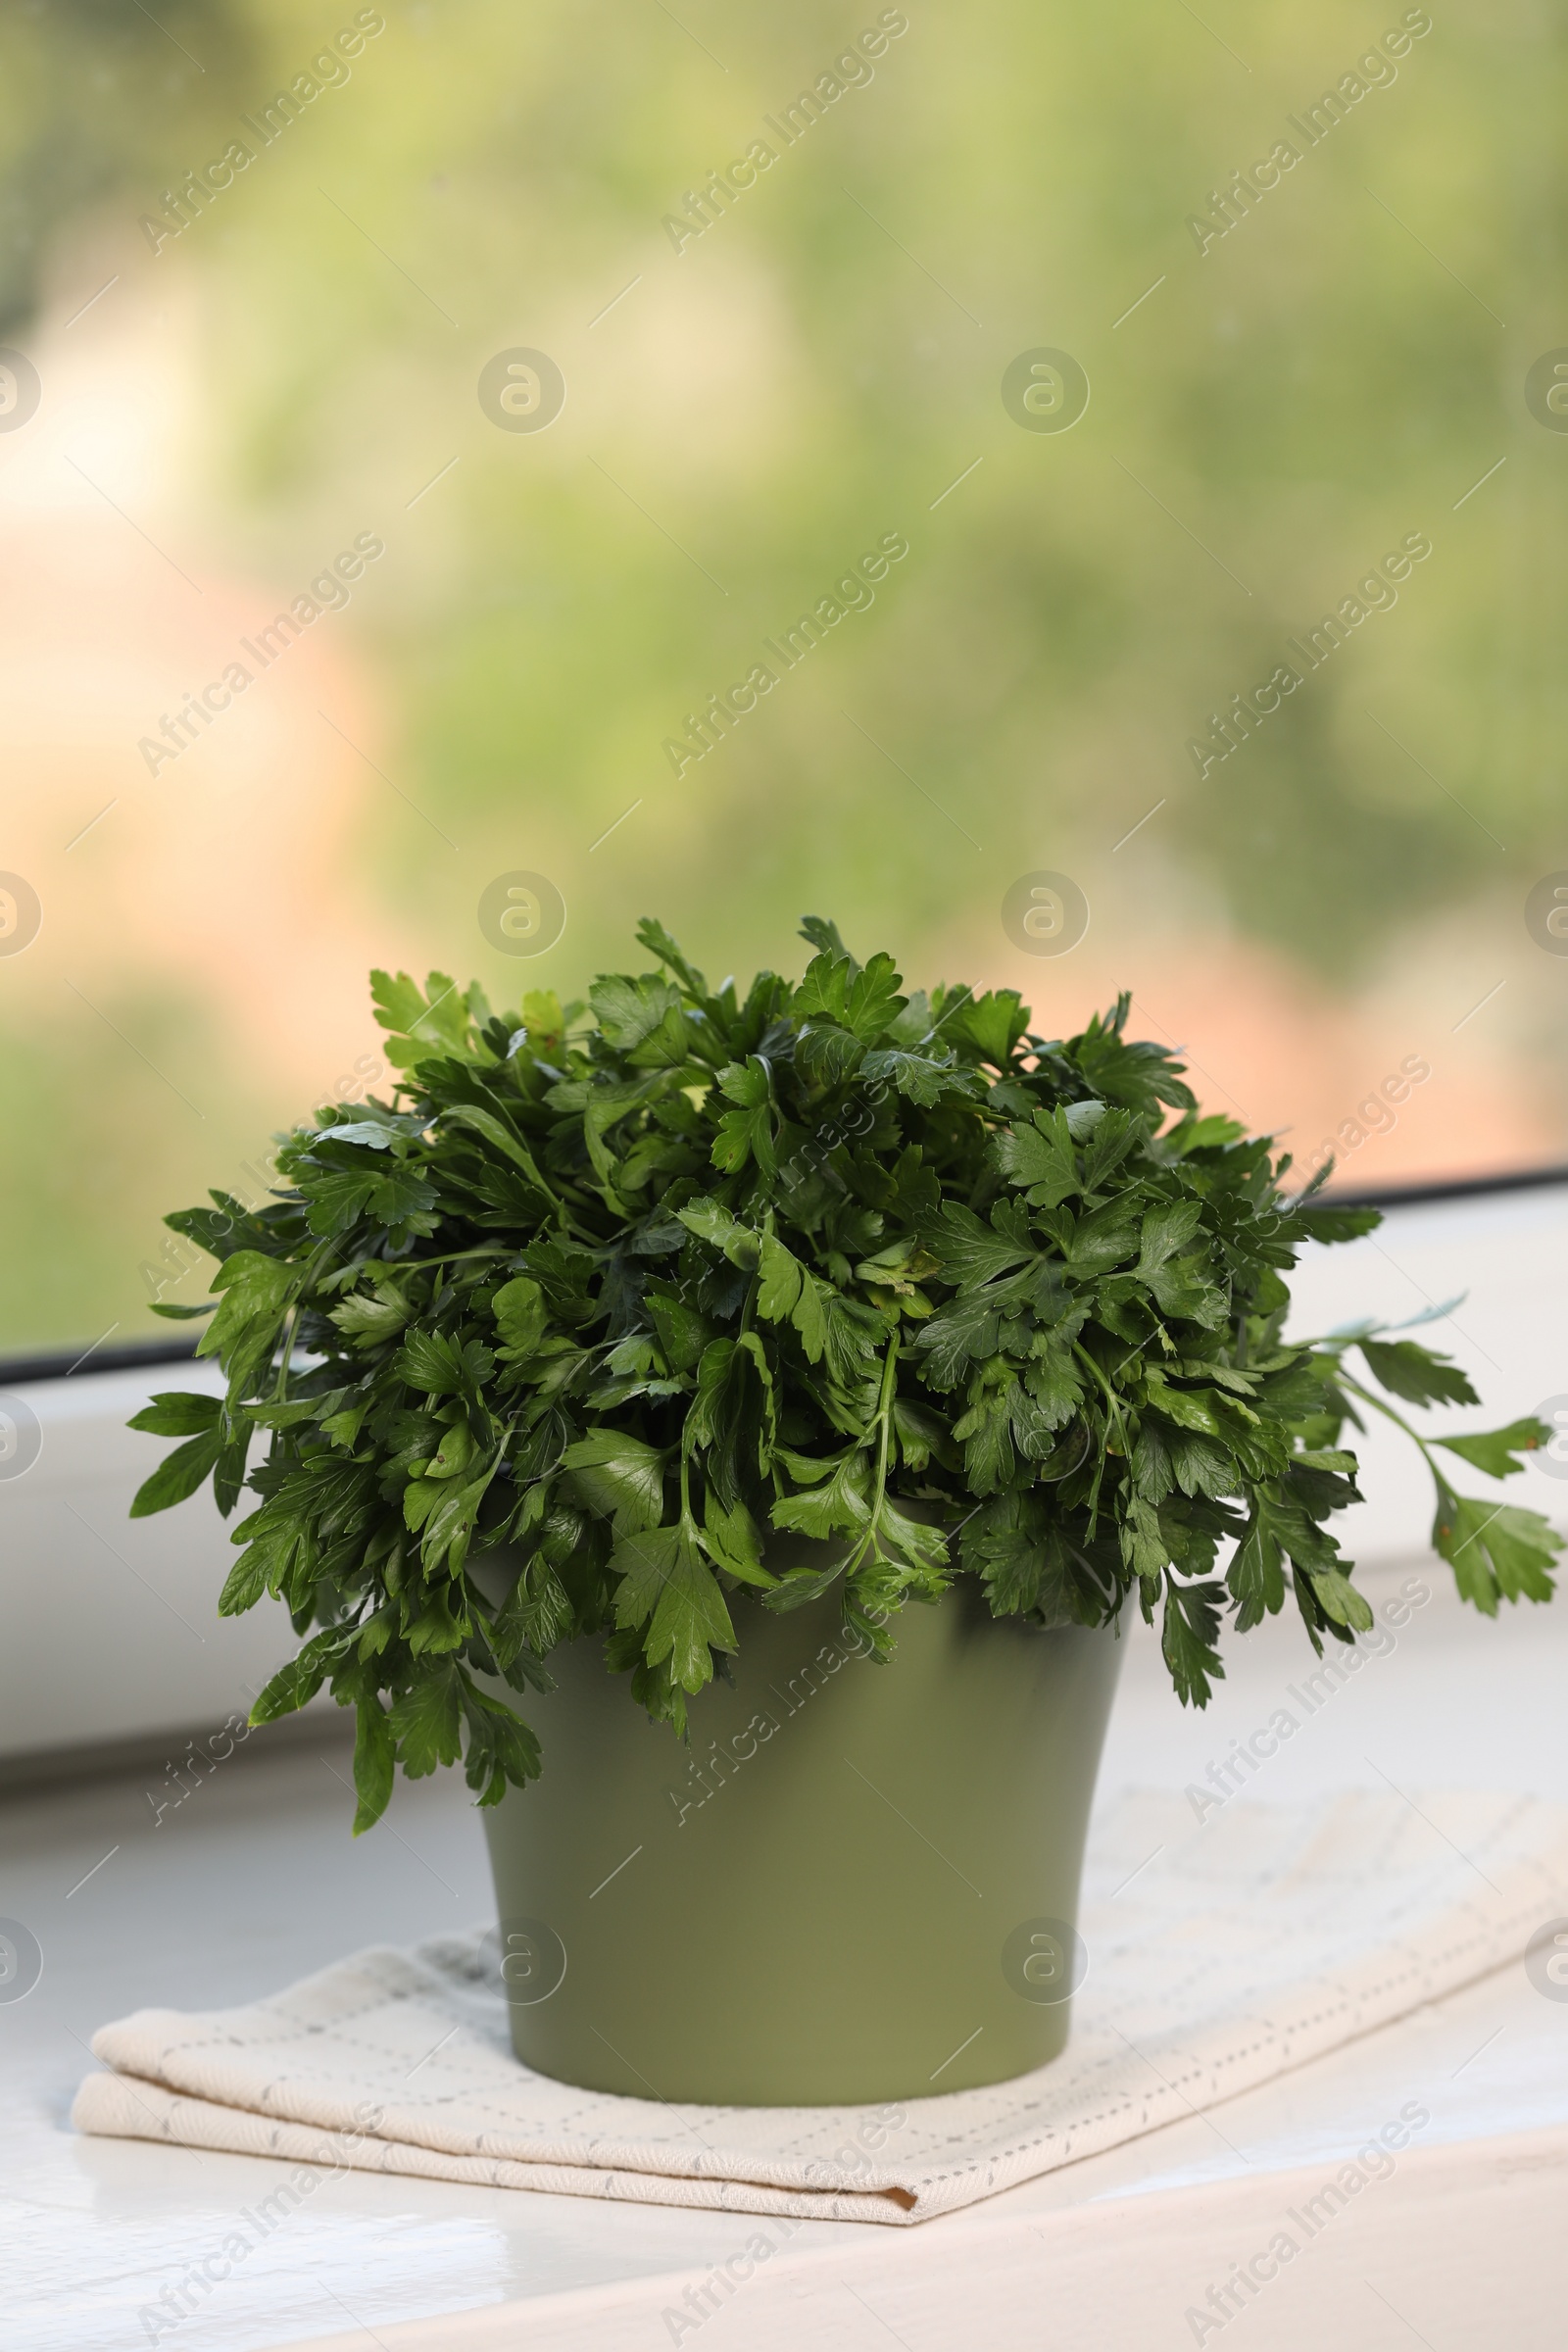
[0,0,1568,1348]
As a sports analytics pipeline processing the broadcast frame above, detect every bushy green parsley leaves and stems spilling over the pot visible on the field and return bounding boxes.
[131,917,1558,1830]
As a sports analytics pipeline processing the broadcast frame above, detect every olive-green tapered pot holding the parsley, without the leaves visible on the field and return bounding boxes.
[484,1581,1121,2107]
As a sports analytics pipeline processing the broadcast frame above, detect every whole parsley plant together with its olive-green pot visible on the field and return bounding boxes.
[134,917,1558,2105]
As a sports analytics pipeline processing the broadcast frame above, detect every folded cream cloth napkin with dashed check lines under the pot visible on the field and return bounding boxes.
[73,1792,1568,2223]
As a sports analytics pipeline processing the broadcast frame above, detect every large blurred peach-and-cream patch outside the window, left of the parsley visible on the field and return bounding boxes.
[0,282,393,1122]
